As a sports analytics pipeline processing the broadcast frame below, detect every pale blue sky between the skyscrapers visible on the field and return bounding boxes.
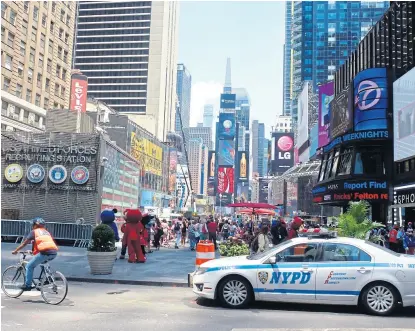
[178,1,285,137]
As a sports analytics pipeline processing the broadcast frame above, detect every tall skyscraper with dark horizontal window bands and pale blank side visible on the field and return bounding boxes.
[74,1,178,141]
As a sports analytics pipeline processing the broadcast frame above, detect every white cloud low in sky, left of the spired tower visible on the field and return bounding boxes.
[190,81,223,126]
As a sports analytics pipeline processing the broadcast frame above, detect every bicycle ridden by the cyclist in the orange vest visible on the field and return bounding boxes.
[1,252,68,305]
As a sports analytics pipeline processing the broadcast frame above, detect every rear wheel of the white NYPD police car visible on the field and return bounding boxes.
[362,283,398,316]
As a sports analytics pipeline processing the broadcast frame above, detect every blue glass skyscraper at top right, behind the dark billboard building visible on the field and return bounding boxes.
[290,1,389,120]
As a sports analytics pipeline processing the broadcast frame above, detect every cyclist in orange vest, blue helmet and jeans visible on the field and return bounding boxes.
[12,217,58,291]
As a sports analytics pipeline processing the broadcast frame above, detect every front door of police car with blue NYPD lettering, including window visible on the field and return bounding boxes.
[256,243,318,302]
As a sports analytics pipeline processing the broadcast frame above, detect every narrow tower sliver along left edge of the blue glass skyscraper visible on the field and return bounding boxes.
[282,1,292,116]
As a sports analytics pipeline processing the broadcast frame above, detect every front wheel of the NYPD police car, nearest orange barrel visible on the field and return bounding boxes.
[218,276,252,308]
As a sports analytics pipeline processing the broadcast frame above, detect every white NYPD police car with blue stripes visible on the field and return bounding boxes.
[193,235,415,315]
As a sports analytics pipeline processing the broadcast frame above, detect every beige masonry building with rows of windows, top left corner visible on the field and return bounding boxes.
[1,1,76,132]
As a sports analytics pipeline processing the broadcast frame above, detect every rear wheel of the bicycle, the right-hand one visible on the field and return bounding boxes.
[40,271,68,305]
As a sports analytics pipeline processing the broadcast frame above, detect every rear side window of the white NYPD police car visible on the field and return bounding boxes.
[322,243,372,262]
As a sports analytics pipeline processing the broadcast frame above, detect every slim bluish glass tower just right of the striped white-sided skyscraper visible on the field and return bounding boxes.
[175,64,192,134]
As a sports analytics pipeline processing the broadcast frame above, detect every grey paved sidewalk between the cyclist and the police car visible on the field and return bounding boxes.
[1,243,203,287]
